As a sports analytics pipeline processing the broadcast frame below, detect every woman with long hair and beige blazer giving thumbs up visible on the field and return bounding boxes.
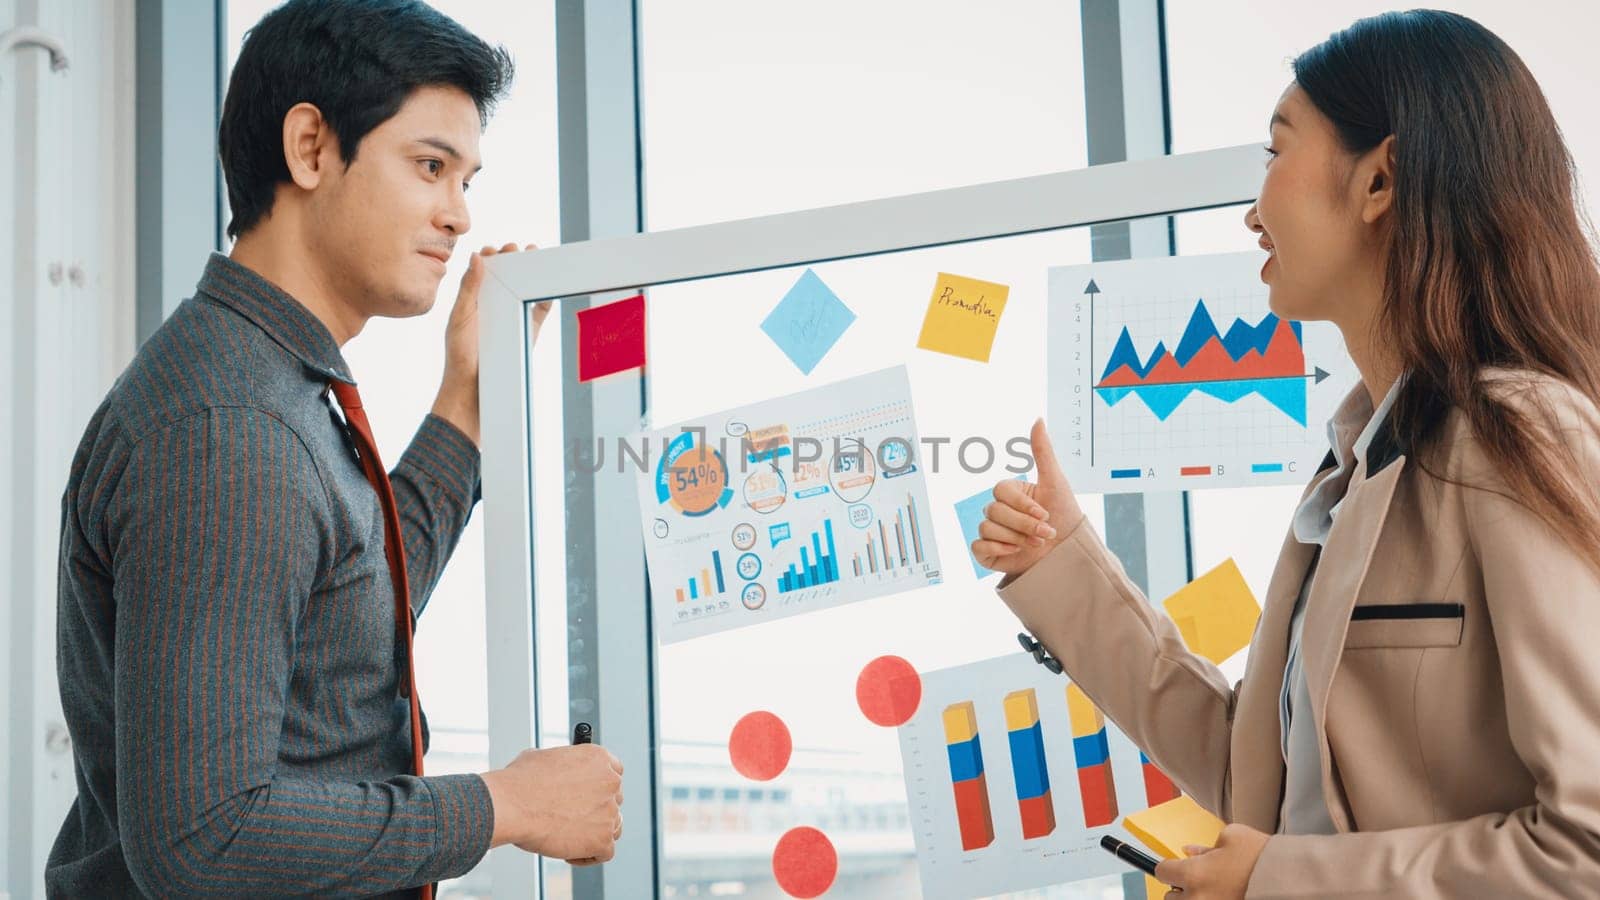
[973,10,1600,900]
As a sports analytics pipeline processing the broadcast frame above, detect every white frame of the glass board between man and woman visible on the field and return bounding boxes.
[478,144,1262,890]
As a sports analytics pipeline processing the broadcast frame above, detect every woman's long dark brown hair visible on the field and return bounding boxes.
[1294,10,1600,565]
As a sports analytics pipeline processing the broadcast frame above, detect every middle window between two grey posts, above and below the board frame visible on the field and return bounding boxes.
[624,7,1139,895]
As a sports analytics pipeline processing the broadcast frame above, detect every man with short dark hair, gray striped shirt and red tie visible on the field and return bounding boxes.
[45,0,622,897]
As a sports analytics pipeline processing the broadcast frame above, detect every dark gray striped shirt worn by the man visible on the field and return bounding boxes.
[45,256,493,897]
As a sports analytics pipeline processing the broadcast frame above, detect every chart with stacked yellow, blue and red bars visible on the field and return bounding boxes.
[899,652,1179,900]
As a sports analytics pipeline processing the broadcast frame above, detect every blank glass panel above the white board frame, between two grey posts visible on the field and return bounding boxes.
[638,0,1086,231]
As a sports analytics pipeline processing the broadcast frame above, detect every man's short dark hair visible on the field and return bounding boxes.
[218,0,512,237]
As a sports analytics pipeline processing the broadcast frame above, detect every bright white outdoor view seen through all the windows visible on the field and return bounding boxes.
[216,0,1600,900]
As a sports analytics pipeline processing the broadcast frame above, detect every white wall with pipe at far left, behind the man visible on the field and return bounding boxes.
[0,0,133,898]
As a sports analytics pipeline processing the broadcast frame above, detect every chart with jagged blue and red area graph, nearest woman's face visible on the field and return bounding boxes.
[1046,253,1358,493]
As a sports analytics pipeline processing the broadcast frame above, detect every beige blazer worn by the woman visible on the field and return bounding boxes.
[998,372,1600,898]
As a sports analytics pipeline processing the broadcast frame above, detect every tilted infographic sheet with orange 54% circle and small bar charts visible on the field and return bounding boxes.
[632,367,941,644]
